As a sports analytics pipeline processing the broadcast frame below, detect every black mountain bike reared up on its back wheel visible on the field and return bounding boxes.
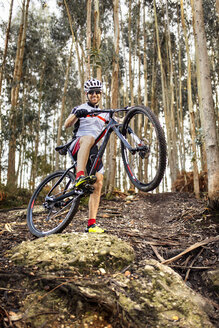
[27,106,166,237]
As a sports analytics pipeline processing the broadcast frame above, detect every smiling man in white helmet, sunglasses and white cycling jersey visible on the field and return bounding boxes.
[65,79,108,233]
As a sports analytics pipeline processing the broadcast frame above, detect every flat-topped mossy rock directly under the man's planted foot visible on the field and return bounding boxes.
[11,233,134,272]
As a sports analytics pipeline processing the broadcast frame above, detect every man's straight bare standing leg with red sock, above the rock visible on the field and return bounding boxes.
[88,172,104,232]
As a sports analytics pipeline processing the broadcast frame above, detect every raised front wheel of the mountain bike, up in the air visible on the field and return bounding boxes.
[121,106,166,192]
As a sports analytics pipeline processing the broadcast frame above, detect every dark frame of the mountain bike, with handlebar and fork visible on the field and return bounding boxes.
[45,107,136,203]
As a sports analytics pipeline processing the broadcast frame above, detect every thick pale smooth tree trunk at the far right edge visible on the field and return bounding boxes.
[191,0,219,207]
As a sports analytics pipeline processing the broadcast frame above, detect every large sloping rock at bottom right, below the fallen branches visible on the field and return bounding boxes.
[117,260,212,328]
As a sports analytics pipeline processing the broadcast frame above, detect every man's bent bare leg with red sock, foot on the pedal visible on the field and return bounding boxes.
[76,136,95,179]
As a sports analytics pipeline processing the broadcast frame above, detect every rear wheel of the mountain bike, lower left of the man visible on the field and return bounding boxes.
[27,171,80,237]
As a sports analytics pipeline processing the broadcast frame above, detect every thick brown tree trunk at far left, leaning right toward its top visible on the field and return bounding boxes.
[7,0,30,188]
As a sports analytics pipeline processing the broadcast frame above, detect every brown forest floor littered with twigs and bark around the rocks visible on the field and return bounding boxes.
[0,192,219,328]
